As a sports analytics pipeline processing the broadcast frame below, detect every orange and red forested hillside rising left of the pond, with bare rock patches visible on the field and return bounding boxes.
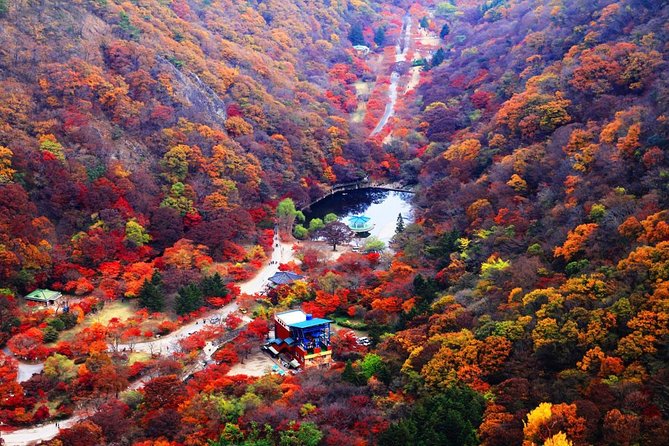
[0,1,384,290]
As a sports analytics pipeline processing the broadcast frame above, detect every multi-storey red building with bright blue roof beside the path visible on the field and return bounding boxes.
[267,310,332,368]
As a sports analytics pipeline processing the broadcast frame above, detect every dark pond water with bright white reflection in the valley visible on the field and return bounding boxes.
[304,189,413,243]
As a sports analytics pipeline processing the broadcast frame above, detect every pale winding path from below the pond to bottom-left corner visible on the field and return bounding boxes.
[0,230,295,446]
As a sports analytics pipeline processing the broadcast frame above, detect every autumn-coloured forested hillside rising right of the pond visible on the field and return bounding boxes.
[382,1,669,445]
